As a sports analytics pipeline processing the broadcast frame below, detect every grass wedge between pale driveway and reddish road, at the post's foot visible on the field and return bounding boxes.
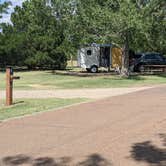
[0,98,89,120]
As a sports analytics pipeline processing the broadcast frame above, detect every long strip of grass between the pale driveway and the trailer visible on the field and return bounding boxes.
[0,71,166,90]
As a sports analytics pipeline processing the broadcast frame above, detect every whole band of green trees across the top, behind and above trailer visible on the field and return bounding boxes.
[0,0,166,71]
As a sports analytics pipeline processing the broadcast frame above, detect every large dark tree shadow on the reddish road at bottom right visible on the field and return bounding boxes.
[131,134,166,166]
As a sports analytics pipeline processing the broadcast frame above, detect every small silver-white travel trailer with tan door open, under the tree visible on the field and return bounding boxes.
[78,44,122,73]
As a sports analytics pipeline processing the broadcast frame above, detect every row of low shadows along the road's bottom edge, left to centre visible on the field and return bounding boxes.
[0,154,112,166]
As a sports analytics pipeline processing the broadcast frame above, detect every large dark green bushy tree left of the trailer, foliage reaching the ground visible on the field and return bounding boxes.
[0,0,67,69]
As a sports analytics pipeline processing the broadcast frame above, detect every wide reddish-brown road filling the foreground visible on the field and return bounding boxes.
[0,86,166,166]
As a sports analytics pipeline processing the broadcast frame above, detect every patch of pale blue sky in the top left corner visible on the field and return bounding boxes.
[0,0,25,23]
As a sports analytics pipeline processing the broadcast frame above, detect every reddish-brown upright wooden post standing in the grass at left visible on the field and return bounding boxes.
[6,67,13,106]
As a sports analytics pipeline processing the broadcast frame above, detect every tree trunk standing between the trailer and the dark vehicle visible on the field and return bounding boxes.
[120,34,129,78]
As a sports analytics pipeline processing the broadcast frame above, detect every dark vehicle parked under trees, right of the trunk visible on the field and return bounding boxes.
[130,53,166,72]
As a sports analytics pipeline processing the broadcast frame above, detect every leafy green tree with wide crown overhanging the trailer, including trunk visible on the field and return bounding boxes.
[65,0,146,76]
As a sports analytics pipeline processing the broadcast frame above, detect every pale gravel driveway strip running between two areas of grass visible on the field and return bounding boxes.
[0,87,151,99]
